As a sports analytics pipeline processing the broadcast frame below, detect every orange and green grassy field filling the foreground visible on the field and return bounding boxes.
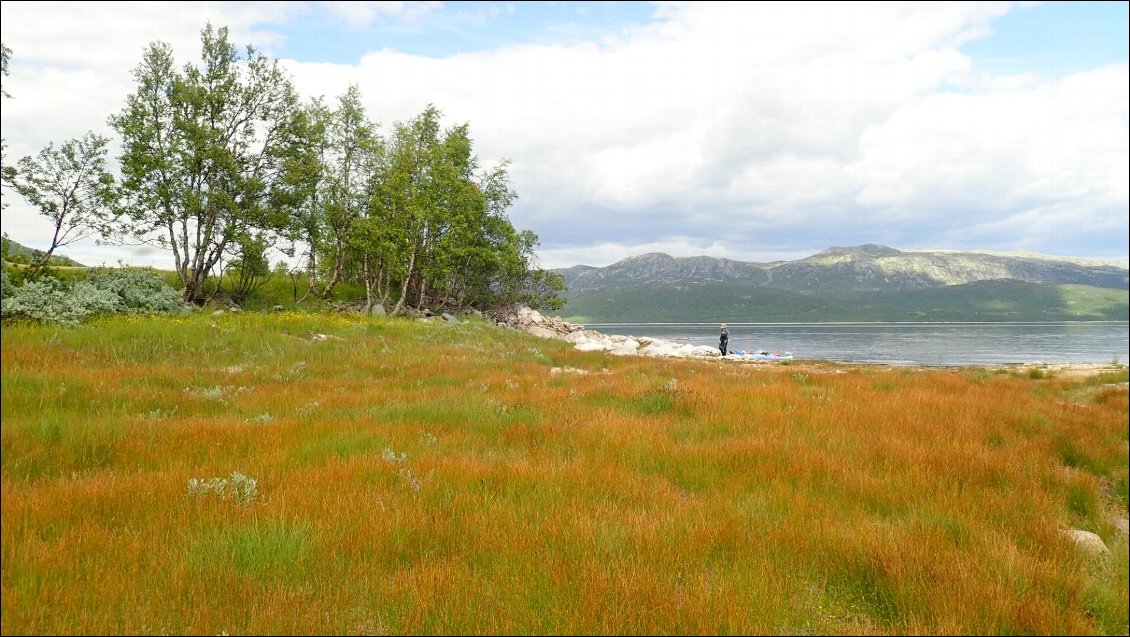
[0,313,1128,635]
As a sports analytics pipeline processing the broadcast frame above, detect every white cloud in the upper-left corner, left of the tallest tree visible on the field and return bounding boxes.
[0,2,303,268]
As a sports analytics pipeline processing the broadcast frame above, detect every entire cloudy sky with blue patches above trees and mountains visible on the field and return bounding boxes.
[0,2,1130,268]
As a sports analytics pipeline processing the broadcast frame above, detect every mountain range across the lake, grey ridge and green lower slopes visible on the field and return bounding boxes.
[554,244,1130,322]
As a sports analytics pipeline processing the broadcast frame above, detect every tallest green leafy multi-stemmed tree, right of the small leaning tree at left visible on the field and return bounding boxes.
[110,25,299,300]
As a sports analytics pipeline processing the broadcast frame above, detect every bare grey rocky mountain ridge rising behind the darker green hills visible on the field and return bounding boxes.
[554,244,1130,295]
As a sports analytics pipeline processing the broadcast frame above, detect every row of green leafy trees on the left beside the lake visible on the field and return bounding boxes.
[3,25,565,313]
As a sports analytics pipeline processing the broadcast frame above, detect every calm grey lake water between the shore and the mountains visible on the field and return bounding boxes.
[584,322,1130,365]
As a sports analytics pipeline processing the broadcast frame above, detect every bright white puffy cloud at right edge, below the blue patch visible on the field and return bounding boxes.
[849,64,1130,225]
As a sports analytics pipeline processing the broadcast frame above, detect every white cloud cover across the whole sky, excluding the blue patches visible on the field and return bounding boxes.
[3,2,1130,267]
